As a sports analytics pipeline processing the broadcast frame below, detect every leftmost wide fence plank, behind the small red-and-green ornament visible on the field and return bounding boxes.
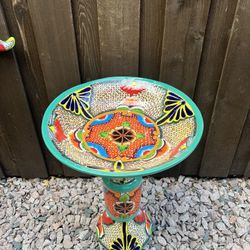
[0,1,48,178]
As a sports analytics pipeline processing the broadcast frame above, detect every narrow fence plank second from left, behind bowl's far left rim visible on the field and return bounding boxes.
[3,0,63,175]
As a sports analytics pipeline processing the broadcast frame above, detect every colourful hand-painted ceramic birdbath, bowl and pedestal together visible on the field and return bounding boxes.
[42,77,203,250]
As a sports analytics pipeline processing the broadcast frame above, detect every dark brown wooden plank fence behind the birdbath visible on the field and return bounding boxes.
[0,0,250,178]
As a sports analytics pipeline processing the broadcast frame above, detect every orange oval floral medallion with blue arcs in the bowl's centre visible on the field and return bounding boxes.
[72,110,160,162]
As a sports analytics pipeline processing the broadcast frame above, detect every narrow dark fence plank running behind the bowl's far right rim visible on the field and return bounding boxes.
[181,0,237,176]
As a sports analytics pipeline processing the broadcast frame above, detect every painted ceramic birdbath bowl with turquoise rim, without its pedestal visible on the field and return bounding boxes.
[42,77,203,177]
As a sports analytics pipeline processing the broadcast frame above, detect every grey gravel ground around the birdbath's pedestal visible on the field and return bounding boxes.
[0,176,250,250]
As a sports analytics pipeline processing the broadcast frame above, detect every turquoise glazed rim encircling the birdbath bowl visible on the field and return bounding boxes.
[42,76,204,178]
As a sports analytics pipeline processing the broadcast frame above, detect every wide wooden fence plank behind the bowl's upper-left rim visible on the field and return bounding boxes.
[28,0,85,176]
